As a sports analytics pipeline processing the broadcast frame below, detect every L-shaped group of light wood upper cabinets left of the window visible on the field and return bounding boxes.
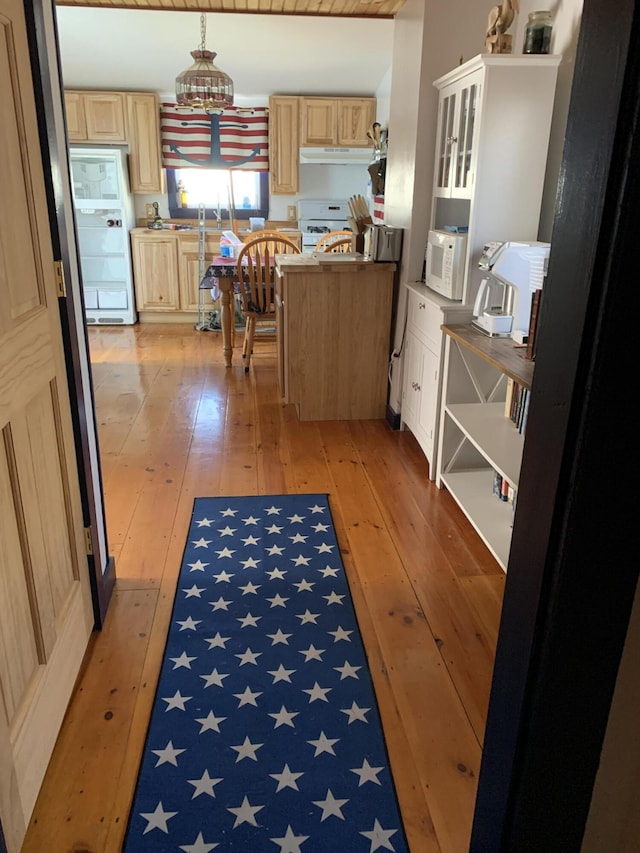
[64,90,165,193]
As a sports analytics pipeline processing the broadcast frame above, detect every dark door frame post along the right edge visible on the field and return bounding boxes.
[471,0,640,853]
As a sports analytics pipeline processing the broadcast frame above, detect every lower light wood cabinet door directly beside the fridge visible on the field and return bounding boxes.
[132,236,180,311]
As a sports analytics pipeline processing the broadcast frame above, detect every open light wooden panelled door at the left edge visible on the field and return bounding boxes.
[0,0,93,853]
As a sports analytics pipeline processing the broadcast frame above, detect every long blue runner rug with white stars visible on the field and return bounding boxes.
[124,494,409,853]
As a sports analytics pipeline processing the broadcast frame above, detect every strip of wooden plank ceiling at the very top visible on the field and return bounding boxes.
[58,0,405,18]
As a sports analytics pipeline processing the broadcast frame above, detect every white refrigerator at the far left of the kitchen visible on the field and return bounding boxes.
[69,147,137,325]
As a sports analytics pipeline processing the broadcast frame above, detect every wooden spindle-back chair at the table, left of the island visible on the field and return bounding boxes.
[238,232,300,373]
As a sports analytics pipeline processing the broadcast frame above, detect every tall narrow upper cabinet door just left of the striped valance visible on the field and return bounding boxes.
[125,93,165,193]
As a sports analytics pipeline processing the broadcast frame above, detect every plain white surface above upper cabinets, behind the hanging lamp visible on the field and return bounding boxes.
[56,5,404,99]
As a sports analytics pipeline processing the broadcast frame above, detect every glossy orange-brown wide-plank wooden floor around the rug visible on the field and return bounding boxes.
[23,325,504,853]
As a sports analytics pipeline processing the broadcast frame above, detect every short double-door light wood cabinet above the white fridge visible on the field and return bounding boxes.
[64,91,126,142]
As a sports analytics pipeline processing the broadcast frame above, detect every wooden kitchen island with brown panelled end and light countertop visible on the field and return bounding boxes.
[276,253,396,421]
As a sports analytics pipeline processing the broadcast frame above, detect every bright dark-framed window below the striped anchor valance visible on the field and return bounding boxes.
[167,168,269,219]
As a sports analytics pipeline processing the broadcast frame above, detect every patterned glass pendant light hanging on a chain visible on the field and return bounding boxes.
[176,15,233,112]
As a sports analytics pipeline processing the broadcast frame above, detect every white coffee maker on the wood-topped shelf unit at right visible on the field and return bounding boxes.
[472,241,551,342]
